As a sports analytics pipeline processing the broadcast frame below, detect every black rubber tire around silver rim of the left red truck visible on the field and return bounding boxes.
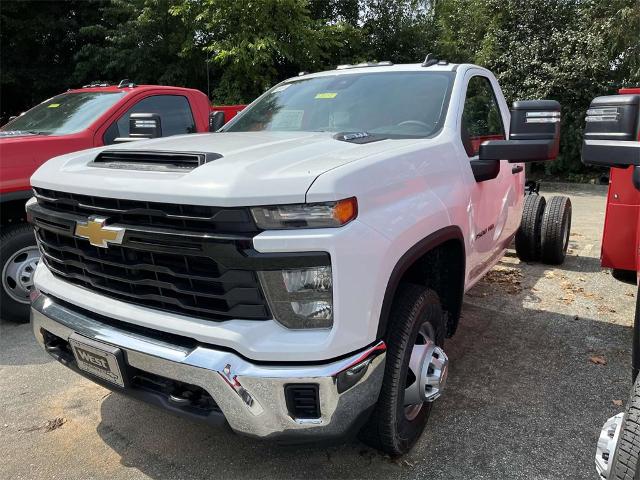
[0,223,36,323]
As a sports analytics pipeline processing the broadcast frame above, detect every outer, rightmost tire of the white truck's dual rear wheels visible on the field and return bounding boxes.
[541,197,571,265]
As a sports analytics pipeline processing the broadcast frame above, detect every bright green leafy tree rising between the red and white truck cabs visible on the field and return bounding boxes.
[172,0,337,102]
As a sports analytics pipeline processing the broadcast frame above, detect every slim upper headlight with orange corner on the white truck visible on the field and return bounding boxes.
[251,197,358,230]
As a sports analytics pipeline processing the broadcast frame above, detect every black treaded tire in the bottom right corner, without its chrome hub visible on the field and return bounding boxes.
[609,381,640,480]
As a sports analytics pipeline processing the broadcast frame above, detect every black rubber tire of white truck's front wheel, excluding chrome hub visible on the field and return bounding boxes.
[360,284,446,456]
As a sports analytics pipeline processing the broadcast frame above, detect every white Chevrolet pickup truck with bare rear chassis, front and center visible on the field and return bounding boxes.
[27,58,571,455]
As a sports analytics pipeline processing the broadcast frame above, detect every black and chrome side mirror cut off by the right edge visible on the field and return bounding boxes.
[582,95,640,168]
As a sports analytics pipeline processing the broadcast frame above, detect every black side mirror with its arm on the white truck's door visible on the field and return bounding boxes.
[479,100,560,163]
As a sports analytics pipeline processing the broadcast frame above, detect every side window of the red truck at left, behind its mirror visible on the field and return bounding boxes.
[104,95,196,145]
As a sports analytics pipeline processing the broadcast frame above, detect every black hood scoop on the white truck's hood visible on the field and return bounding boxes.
[89,150,222,172]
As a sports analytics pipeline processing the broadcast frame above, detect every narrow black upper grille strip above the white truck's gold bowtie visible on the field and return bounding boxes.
[34,188,259,233]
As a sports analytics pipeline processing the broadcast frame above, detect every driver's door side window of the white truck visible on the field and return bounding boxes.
[460,76,505,157]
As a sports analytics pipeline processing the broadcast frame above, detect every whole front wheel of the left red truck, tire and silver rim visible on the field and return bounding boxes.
[0,224,40,323]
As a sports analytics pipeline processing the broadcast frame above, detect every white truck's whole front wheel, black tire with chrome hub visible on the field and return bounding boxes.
[360,284,448,456]
